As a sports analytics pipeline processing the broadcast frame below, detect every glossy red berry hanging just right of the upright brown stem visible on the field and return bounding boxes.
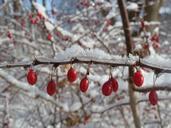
[133,71,144,87]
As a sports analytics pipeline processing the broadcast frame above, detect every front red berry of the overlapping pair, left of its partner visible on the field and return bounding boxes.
[102,80,112,96]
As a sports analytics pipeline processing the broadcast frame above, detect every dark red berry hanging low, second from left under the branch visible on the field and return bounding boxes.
[47,80,56,96]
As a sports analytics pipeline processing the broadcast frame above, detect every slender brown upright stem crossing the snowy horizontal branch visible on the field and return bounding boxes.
[118,0,141,128]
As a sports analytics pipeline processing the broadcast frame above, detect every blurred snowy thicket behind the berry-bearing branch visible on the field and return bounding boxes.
[0,0,171,128]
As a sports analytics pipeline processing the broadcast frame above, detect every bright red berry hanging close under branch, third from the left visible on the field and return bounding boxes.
[67,67,77,83]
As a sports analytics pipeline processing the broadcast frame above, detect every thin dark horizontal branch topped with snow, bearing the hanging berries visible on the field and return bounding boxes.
[0,56,171,73]
